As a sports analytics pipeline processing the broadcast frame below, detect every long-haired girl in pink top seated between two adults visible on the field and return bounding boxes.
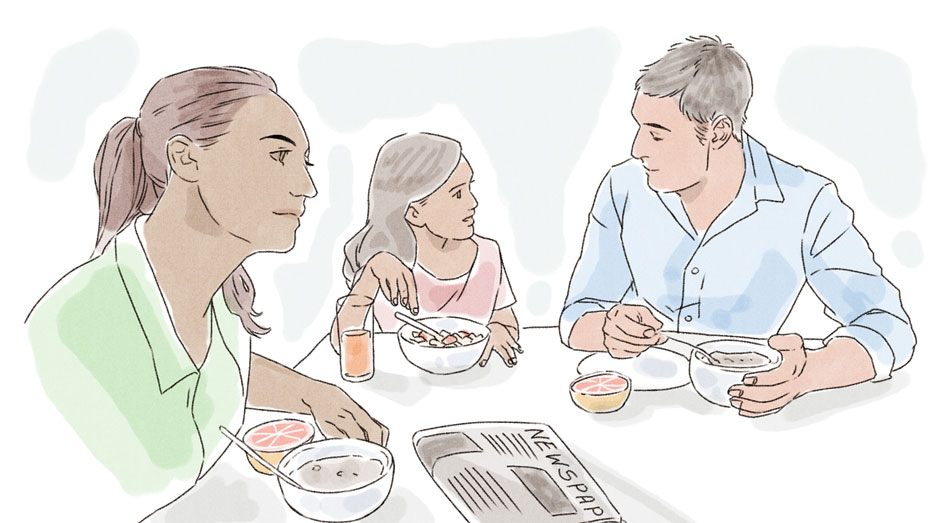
[330,133,521,367]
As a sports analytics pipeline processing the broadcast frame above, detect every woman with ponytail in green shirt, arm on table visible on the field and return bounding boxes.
[27,67,388,512]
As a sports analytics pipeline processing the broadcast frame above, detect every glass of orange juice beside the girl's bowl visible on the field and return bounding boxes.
[337,295,375,382]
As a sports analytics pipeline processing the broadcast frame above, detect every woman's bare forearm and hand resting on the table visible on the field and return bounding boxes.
[247,354,389,445]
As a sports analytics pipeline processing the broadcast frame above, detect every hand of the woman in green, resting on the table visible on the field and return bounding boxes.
[302,381,389,446]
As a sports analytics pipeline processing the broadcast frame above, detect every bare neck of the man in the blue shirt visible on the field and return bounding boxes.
[677,139,745,235]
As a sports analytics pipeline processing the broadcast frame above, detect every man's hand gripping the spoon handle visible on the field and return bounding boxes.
[604,304,666,358]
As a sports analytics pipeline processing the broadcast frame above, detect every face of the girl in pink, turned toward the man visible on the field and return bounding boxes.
[406,160,478,240]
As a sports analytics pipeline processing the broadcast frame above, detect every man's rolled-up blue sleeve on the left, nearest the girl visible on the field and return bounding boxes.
[558,173,633,345]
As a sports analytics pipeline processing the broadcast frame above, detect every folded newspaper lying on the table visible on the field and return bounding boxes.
[412,423,623,523]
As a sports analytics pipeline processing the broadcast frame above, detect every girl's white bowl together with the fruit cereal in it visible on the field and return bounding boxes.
[397,317,489,374]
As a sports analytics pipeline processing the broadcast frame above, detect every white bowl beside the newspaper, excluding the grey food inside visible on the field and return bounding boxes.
[278,439,394,522]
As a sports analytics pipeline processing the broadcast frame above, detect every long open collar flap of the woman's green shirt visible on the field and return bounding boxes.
[114,216,198,394]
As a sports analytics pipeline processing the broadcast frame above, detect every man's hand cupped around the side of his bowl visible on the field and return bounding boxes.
[729,334,810,418]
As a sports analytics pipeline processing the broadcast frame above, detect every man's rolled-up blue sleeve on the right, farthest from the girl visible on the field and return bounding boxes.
[802,183,916,381]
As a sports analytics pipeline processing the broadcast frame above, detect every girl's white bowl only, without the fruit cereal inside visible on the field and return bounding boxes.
[397,317,489,374]
